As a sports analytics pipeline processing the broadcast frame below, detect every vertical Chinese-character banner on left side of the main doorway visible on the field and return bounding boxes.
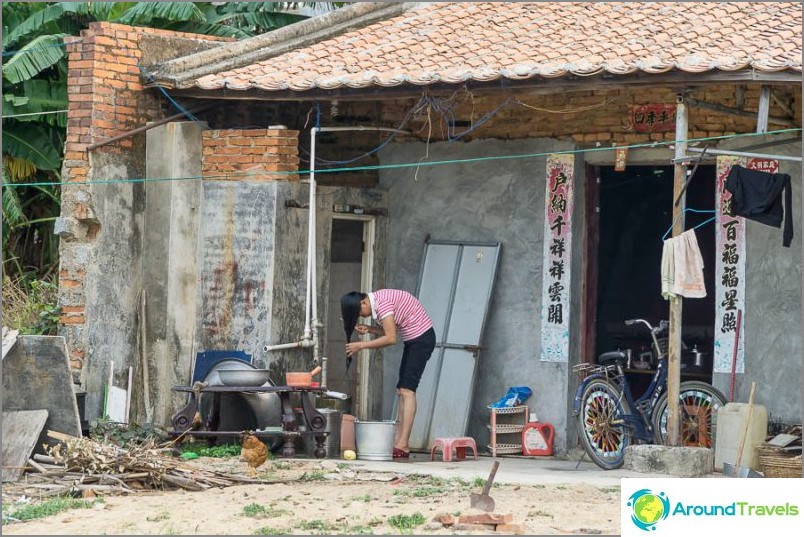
[541,155,575,362]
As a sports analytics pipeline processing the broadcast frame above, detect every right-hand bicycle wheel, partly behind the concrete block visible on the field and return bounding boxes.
[651,380,726,449]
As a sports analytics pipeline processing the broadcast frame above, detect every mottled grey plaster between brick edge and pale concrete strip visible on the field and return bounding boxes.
[75,151,145,420]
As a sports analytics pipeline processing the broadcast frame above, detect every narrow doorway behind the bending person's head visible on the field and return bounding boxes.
[325,215,379,419]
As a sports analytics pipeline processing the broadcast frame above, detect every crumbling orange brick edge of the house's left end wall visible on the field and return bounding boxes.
[56,22,228,382]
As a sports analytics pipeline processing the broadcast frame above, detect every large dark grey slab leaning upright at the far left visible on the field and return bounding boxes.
[3,336,81,453]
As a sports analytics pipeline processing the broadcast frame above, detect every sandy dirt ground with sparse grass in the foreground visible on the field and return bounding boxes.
[3,457,620,535]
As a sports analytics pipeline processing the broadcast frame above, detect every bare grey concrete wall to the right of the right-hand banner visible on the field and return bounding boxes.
[713,137,804,424]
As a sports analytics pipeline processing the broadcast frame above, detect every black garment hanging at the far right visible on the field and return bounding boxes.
[726,165,793,248]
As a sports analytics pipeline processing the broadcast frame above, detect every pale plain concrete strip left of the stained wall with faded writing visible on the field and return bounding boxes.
[145,122,206,424]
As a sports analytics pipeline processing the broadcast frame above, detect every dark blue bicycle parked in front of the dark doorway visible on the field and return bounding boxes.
[572,319,726,470]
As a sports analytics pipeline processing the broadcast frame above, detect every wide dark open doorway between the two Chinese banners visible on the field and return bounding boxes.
[588,162,715,386]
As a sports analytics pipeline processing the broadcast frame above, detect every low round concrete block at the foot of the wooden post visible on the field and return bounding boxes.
[623,445,715,477]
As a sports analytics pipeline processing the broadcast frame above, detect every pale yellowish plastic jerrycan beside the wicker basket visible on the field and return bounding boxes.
[715,403,768,471]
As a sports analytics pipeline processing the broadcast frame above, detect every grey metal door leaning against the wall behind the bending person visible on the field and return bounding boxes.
[410,241,501,449]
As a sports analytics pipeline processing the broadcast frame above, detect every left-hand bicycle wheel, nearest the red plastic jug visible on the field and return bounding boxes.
[578,380,631,470]
